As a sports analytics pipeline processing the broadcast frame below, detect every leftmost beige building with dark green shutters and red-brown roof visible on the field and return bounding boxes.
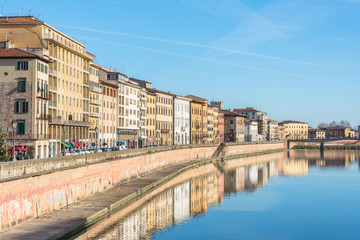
[0,45,49,158]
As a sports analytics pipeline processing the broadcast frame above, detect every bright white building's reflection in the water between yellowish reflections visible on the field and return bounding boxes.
[174,182,190,223]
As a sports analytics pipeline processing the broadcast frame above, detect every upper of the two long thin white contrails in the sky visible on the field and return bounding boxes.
[59,25,324,67]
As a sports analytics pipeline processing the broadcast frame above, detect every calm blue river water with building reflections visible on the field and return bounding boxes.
[77,150,360,240]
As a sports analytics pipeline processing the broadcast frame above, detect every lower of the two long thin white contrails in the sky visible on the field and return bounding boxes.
[73,35,346,86]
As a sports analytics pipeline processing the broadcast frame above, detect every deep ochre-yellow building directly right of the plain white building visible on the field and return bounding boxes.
[186,95,208,143]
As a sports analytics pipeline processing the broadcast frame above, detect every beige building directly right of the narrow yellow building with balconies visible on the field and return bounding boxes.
[97,79,118,147]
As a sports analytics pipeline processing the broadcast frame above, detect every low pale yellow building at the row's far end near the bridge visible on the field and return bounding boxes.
[279,121,308,139]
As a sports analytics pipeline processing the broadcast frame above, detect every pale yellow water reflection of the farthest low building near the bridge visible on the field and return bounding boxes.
[279,160,309,176]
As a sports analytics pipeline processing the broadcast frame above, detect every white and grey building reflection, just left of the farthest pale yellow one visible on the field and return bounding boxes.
[245,163,269,192]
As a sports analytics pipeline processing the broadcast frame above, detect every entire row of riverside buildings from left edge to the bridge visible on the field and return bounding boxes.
[0,16,358,158]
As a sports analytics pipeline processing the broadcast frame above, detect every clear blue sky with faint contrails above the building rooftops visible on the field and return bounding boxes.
[0,0,360,127]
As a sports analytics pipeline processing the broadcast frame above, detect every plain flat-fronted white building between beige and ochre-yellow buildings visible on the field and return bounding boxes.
[173,95,191,145]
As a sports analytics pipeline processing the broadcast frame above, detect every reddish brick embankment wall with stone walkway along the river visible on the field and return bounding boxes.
[0,143,284,239]
